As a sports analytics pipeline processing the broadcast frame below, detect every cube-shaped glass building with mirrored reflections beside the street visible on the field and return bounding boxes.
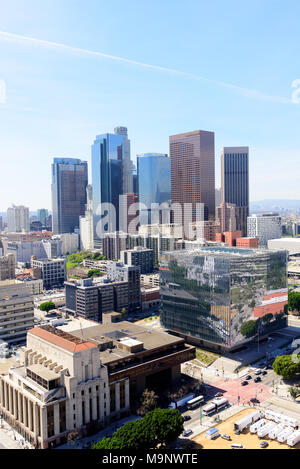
[160,248,287,349]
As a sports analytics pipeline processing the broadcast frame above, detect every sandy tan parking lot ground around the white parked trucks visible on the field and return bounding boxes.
[192,409,300,449]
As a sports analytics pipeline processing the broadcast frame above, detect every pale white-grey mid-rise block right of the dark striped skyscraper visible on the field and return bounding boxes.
[248,213,282,248]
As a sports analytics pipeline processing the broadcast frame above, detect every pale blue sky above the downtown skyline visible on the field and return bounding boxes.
[0,0,300,211]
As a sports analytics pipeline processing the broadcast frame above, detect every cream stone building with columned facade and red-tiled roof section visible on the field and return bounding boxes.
[0,313,195,448]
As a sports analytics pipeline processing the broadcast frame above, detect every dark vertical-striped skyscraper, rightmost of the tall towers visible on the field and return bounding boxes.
[221,147,249,236]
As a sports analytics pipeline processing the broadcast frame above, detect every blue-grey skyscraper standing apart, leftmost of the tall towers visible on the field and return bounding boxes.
[52,158,88,234]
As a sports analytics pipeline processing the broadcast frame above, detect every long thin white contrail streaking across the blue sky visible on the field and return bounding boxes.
[0,31,292,104]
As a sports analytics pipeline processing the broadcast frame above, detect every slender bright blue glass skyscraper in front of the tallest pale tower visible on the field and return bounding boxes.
[92,130,125,243]
